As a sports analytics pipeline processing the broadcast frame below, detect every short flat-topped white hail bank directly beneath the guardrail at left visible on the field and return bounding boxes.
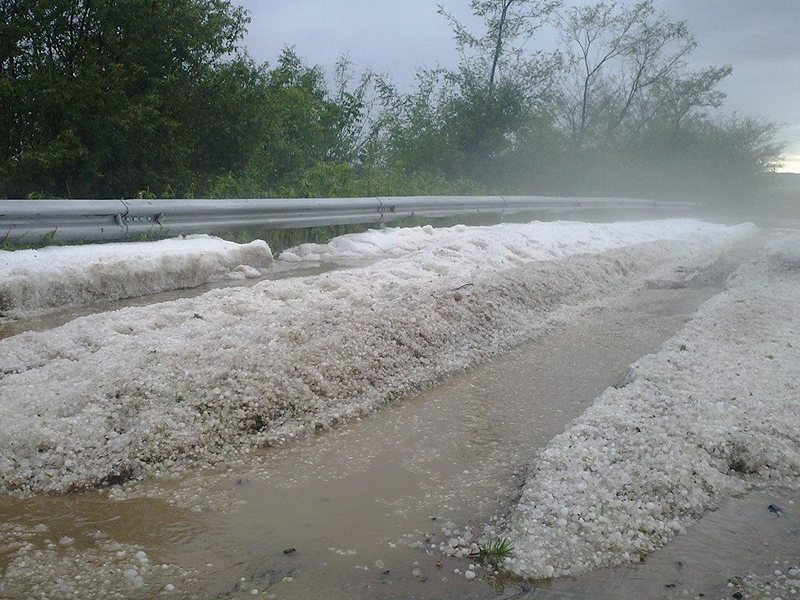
[0,235,272,318]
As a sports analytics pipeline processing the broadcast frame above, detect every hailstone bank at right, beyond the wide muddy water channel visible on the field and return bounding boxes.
[508,236,800,578]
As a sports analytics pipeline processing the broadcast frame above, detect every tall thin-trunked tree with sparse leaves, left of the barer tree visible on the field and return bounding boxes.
[378,0,559,182]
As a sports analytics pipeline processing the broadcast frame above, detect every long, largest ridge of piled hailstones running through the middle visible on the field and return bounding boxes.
[0,221,753,493]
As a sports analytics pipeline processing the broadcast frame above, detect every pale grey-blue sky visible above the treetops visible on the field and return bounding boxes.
[239,0,800,172]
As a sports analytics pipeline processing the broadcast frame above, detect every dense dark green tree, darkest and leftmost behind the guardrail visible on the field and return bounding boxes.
[0,0,253,196]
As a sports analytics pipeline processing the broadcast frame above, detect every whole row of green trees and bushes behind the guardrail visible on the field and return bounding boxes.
[0,0,781,203]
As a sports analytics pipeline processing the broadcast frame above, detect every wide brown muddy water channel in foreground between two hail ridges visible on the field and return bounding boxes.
[0,251,788,600]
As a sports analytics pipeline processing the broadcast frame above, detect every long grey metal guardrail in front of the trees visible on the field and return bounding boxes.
[0,196,695,243]
